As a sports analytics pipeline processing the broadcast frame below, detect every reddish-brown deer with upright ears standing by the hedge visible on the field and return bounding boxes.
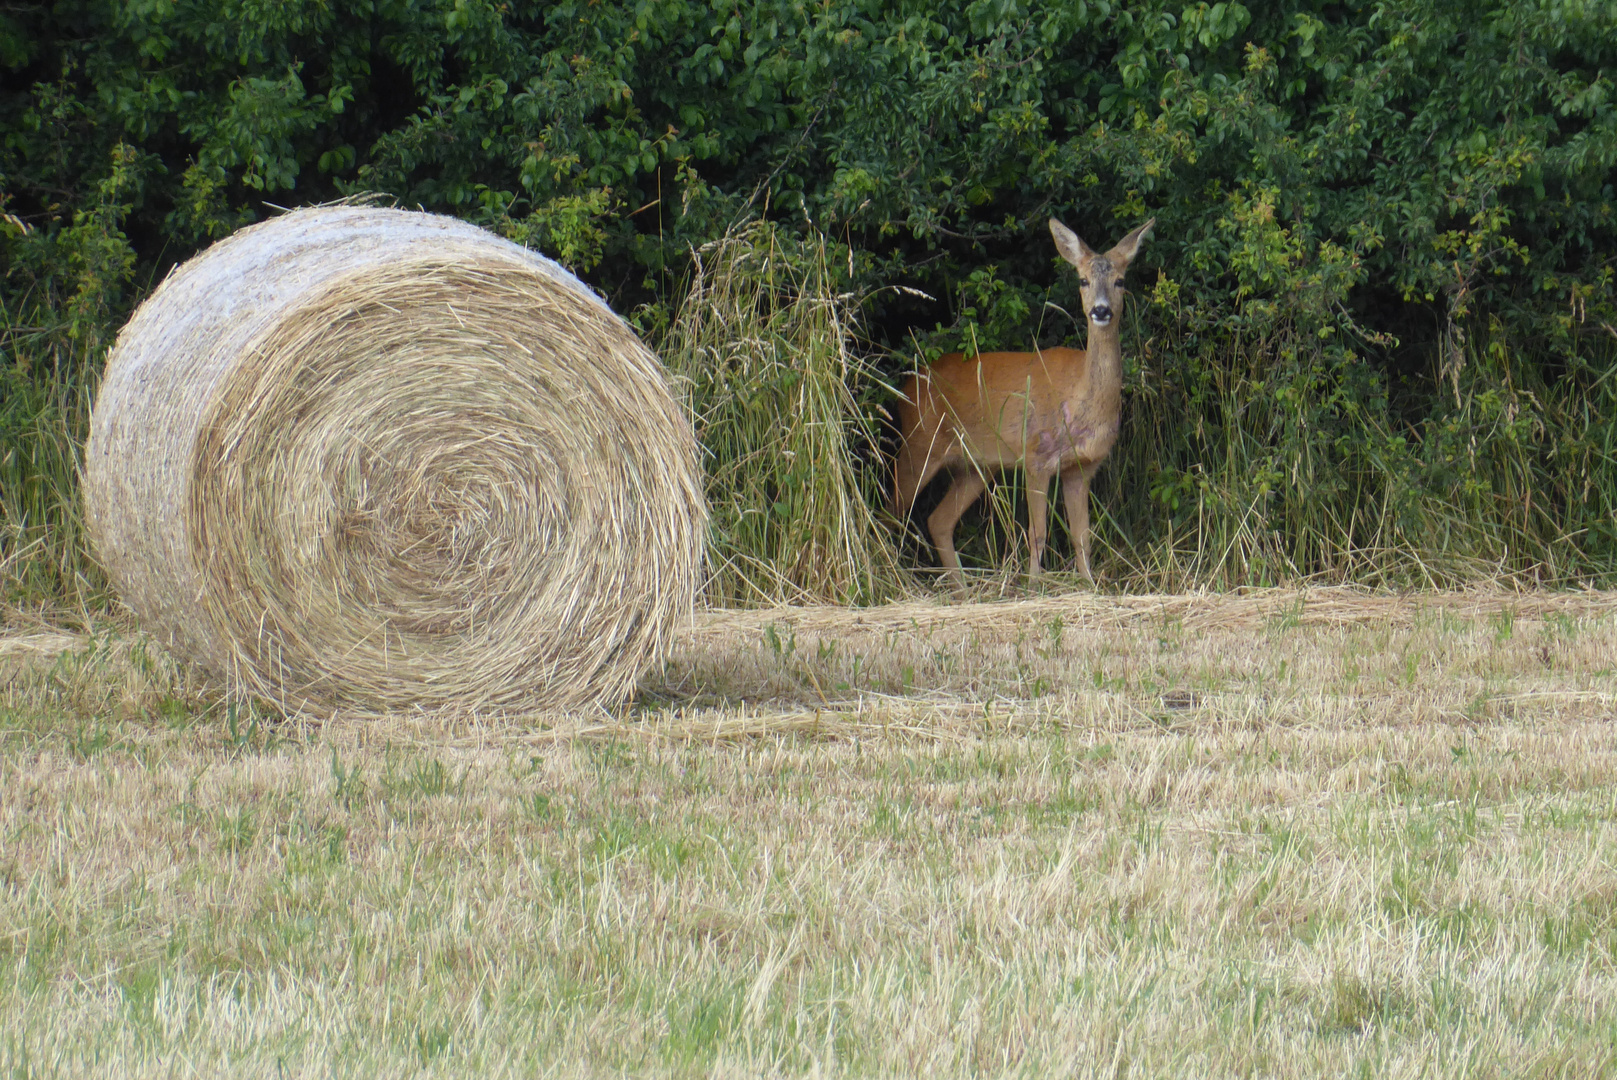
[891,218,1156,590]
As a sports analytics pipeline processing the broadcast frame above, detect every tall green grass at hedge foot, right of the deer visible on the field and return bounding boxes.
[1095,284,1617,590]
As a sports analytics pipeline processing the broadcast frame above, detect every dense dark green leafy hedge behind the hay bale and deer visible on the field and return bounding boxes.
[0,0,1617,607]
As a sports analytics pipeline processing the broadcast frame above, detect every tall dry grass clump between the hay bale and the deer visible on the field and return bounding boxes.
[663,221,906,605]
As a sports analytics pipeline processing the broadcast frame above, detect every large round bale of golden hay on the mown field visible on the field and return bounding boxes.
[84,205,707,711]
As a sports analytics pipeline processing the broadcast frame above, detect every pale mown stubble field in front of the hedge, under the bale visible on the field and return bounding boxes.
[0,590,1617,1077]
